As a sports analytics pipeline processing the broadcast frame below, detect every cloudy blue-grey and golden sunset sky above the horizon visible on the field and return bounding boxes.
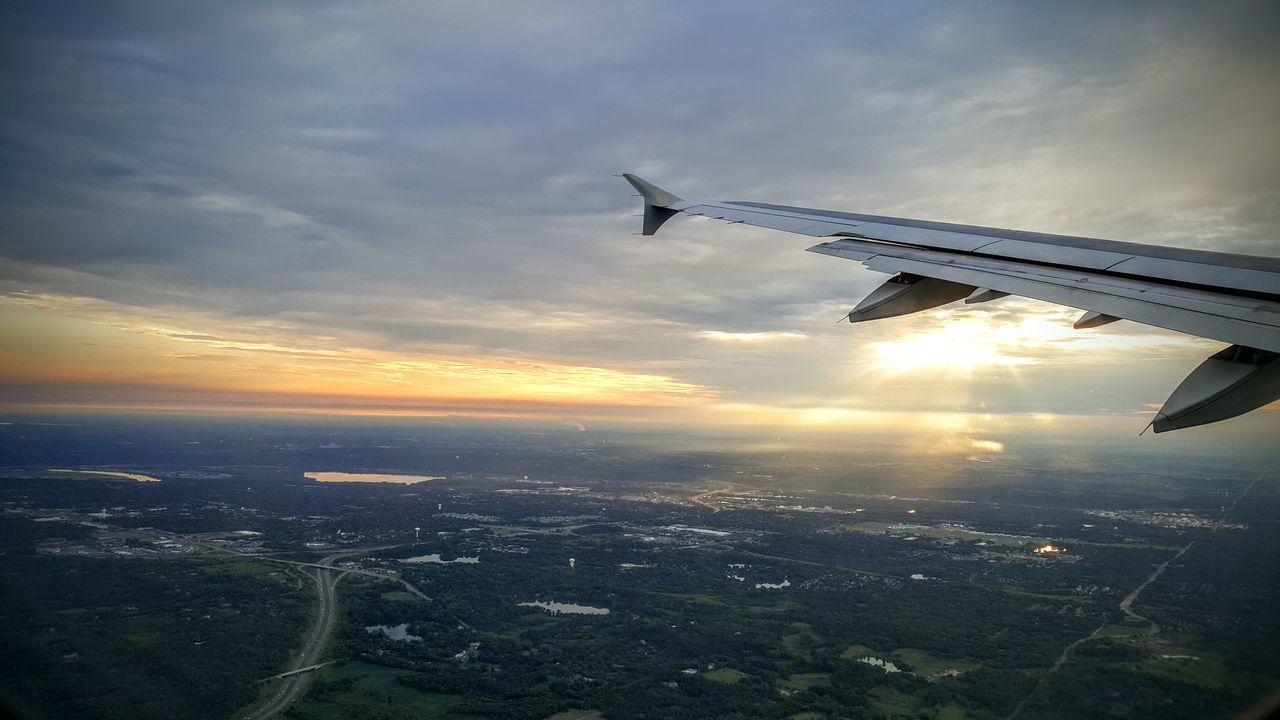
[0,1,1280,442]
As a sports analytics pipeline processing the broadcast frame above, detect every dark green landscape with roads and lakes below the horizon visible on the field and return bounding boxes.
[0,418,1280,720]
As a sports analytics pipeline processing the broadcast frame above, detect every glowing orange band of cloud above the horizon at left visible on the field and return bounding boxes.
[0,296,716,413]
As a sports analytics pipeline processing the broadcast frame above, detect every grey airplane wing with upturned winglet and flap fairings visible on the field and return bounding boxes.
[622,173,1280,433]
